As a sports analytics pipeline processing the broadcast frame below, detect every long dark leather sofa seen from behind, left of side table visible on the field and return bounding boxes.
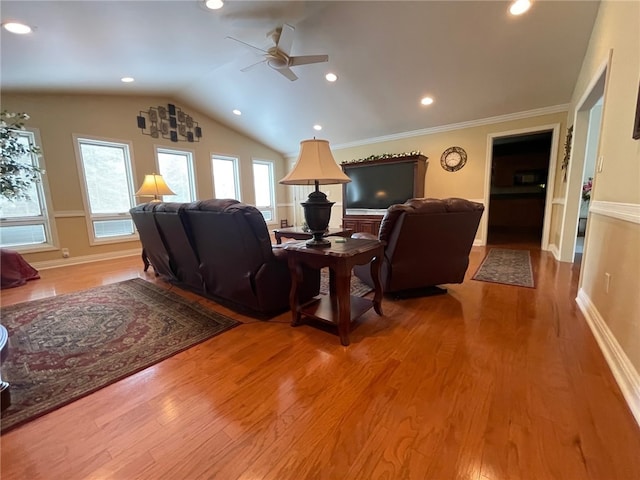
[130,199,320,318]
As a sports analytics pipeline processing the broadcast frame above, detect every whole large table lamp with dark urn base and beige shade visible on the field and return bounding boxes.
[280,138,351,247]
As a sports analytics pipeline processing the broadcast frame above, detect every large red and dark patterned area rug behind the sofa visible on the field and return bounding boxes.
[0,278,240,433]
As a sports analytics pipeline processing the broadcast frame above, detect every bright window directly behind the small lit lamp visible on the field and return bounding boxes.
[156,148,196,202]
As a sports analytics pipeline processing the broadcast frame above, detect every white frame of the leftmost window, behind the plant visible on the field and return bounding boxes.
[0,127,58,253]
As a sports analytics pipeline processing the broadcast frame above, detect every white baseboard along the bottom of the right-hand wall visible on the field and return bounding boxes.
[576,289,640,426]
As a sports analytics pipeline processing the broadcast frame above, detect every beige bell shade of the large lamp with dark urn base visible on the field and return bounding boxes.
[280,138,351,185]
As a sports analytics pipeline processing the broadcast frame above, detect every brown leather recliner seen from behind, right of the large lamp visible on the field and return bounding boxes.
[353,198,484,296]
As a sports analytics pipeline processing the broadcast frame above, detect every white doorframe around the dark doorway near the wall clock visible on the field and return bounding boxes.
[480,123,560,250]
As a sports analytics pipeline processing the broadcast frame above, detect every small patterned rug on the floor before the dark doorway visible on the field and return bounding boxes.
[472,248,535,288]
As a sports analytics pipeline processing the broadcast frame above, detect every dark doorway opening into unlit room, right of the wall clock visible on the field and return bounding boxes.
[487,130,554,247]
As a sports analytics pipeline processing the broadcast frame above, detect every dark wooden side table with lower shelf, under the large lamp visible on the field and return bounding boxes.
[284,238,384,346]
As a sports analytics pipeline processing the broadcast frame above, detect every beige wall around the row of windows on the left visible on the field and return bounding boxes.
[2,92,286,262]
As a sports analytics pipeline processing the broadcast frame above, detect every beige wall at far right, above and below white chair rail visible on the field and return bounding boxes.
[568,1,640,378]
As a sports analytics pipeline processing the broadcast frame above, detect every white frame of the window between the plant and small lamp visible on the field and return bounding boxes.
[73,134,140,246]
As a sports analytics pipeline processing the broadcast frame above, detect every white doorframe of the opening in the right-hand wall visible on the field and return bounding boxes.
[558,55,612,262]
